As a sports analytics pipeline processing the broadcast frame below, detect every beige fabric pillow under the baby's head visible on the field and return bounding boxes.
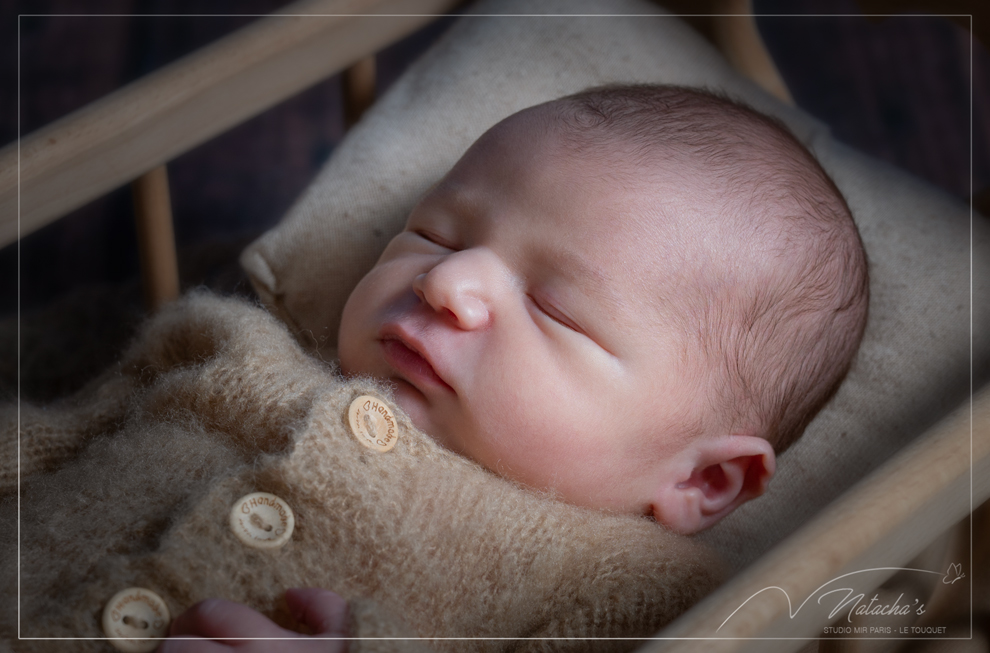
[241,0,990,568]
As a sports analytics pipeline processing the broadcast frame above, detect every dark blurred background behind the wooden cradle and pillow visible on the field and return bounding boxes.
[0,0,990,399]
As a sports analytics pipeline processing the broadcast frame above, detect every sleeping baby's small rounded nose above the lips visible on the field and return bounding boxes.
[413,252,500,331]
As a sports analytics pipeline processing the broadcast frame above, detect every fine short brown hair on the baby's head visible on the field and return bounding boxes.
[553,85,869,454]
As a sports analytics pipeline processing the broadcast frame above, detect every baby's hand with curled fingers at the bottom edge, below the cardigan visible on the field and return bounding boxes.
[158,588,348,653]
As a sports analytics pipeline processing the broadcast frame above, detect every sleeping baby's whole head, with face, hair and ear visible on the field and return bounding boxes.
[339,86,868,533]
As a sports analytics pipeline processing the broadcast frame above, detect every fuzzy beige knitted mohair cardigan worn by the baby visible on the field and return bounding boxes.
[0,292,720,651]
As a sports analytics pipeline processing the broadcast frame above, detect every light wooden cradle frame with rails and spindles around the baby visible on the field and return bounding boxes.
[0,0,990,651]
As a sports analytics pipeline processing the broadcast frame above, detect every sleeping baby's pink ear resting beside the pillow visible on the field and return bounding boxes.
[653,435,777,535]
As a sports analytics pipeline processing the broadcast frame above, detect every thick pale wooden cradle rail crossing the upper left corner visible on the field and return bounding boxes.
[0,0,457,246]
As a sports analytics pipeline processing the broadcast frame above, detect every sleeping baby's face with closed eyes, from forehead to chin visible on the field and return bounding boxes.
[339,112,703,514]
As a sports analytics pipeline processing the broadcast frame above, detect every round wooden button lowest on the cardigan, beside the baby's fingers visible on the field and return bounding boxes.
[103,587,171,653]
